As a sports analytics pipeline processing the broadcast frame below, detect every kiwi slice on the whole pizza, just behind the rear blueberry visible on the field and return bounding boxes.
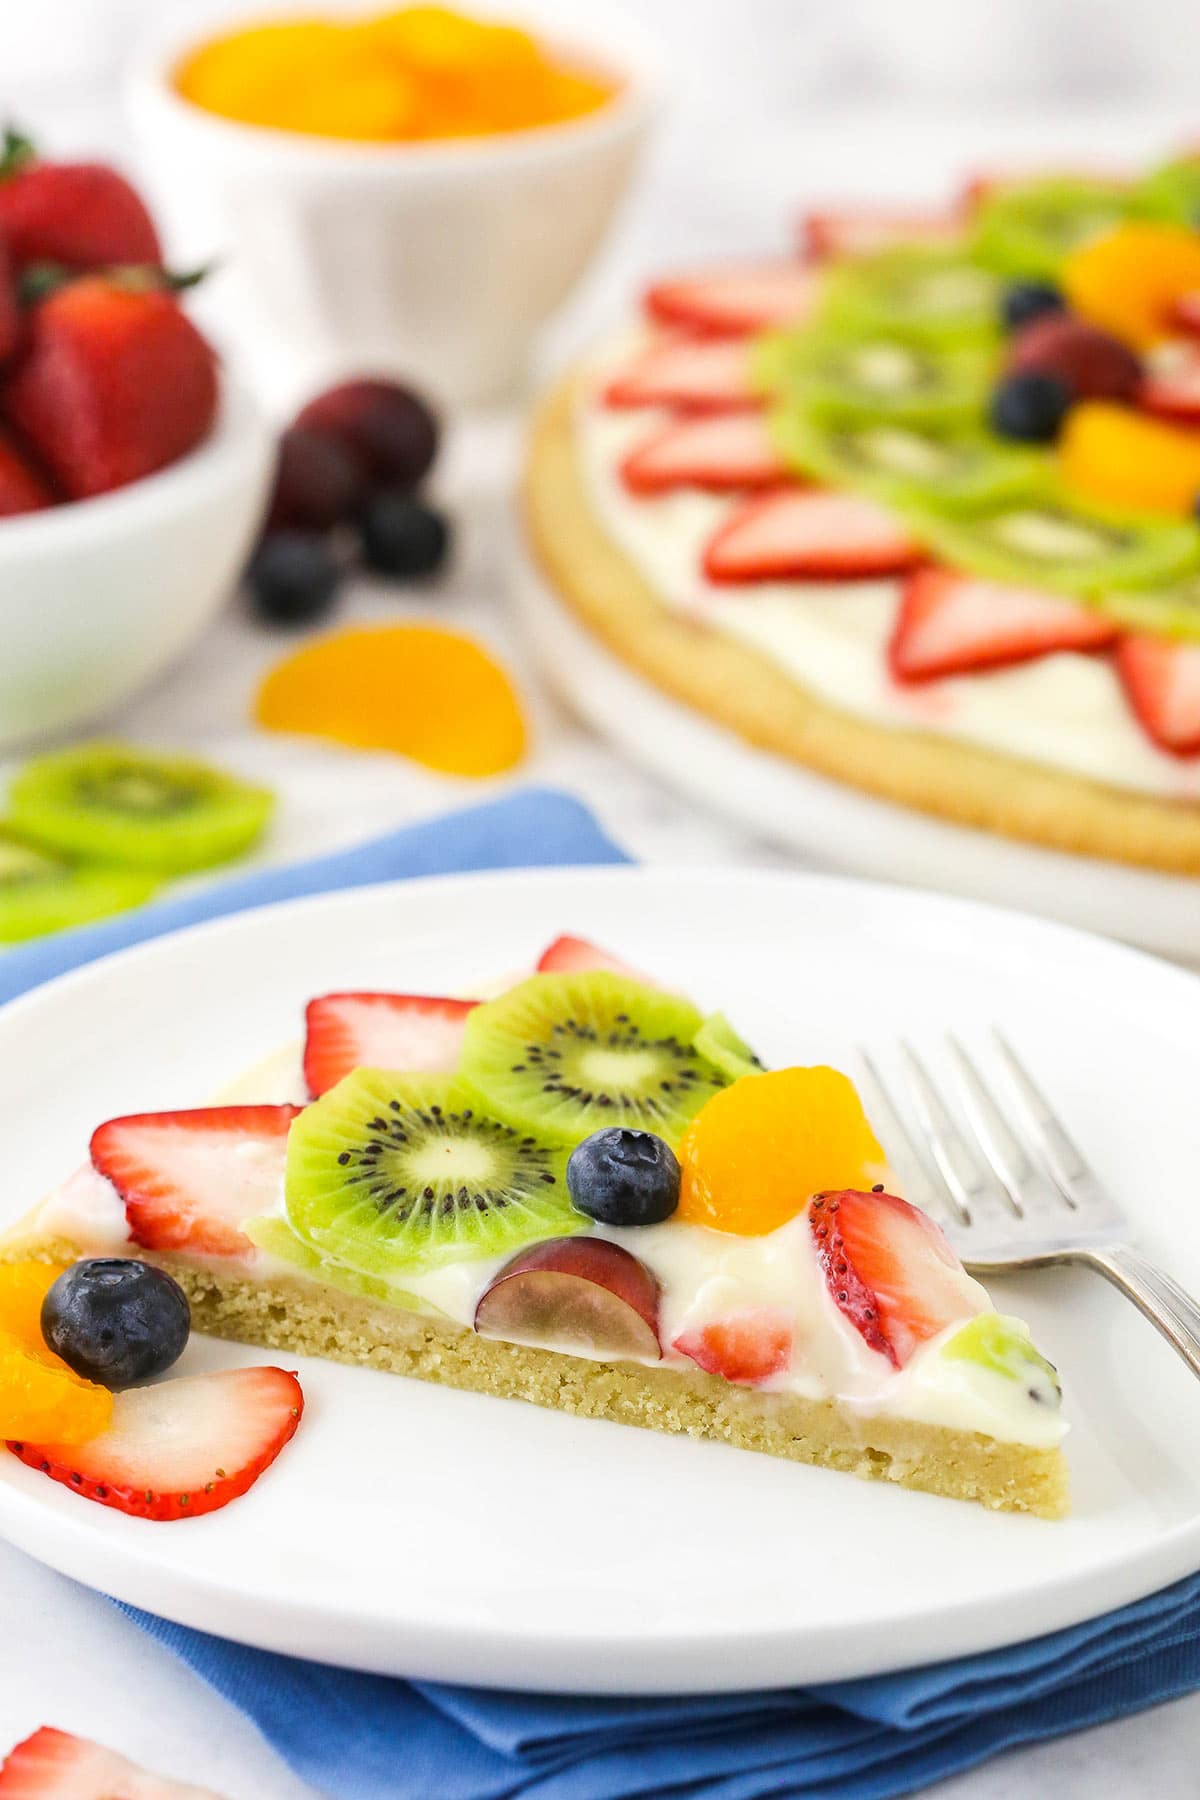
[975,176,1137,279]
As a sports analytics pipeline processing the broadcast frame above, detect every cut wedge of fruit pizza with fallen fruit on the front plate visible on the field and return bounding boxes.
[0,938,1067,1517]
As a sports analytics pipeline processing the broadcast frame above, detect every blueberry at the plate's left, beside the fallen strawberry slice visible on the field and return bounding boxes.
[41,1256,191,1388]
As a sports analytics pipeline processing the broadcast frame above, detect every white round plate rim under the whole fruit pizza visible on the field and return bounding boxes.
[513,547,1200,963]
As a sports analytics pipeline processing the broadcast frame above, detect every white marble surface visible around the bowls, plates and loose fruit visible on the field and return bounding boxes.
[0,10,1200,1800]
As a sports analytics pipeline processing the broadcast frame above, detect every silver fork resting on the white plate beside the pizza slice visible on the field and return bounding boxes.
[860,1031,1200,1375]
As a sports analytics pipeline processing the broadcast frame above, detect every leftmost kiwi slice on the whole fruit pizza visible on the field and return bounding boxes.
[770,329,997,425]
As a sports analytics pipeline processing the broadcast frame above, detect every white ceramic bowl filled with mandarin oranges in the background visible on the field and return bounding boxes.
[126,0,658,403]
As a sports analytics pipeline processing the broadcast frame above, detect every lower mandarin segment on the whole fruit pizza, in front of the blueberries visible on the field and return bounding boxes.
[1058,400,1200,518]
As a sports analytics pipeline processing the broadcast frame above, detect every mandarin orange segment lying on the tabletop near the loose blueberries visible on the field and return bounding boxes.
[255,625,525,776]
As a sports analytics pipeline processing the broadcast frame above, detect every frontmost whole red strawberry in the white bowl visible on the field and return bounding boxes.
[0,268,218,500]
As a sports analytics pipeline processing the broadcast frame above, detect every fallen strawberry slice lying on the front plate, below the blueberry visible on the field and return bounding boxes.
[9,1364,304,1519]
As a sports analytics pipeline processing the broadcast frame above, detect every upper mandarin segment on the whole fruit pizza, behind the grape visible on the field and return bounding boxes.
[1061,220,1200,349]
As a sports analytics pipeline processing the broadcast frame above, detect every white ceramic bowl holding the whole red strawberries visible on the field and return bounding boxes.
[0,378,275,747]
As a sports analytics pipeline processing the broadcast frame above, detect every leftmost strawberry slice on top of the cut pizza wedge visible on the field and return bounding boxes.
[92,1107,300,1256]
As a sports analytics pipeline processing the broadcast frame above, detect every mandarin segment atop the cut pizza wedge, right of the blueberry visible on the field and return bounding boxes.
[676,1067,887,1237]
